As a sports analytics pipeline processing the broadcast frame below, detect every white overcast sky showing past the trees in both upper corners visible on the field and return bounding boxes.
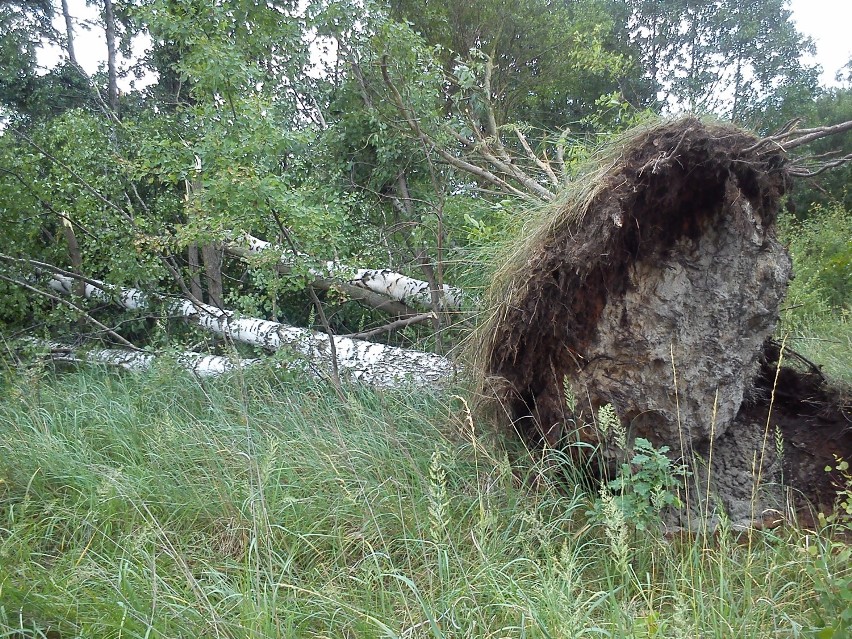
[44,0,852,86]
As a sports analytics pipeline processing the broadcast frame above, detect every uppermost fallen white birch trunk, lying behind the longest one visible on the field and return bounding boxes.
[233,234,462,310]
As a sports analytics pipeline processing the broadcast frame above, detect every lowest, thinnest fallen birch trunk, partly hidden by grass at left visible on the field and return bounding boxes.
[27,339,260,377]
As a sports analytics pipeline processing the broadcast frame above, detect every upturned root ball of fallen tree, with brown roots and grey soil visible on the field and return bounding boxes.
[479,117,852,524]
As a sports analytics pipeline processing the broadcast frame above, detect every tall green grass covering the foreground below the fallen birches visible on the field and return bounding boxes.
[0,369,849,639]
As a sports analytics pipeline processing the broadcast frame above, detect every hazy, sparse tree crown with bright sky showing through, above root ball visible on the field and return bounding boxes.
[609,0,817,125]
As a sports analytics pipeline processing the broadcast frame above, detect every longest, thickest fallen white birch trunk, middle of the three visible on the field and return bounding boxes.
[49,275,453,387]
